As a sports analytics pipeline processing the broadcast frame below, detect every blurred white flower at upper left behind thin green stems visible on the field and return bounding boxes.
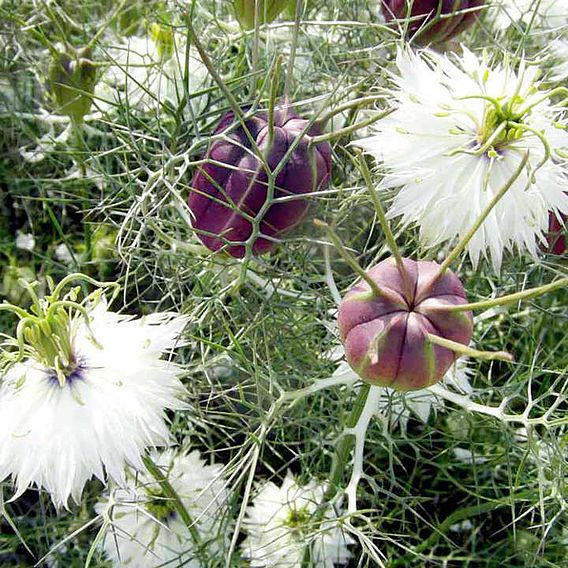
[94,30,208,114]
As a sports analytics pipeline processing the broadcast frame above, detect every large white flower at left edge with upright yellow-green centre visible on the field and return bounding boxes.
[0,277,187,507]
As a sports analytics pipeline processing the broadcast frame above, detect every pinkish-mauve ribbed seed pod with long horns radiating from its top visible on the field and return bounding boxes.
[338,258,473,391]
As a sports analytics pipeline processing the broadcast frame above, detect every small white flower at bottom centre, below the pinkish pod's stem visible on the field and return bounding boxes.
[242,473,354,568]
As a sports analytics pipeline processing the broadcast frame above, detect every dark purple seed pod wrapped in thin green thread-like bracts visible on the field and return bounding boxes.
[189,106,331,258]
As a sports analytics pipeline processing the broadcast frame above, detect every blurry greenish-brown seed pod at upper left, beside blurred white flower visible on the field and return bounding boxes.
[48,46,96,122]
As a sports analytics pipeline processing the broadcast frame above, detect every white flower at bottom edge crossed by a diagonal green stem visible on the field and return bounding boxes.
[95,450,229,568]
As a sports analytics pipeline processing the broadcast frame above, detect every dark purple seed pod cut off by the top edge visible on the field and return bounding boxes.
[382,0,484,45]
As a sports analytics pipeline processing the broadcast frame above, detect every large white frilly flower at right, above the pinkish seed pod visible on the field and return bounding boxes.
[356,48,568,269]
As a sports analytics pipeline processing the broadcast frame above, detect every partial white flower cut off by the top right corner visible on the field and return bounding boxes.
[491,0,568,31]
